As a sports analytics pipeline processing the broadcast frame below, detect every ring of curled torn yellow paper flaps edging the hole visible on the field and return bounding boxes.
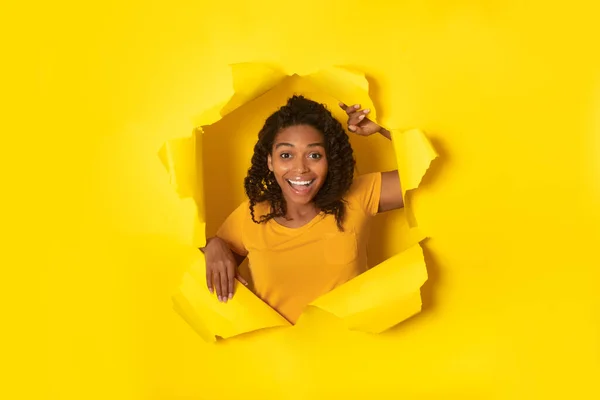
[159,64,437,341]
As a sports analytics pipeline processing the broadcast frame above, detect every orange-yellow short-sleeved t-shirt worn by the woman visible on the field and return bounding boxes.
[217,173,381,323]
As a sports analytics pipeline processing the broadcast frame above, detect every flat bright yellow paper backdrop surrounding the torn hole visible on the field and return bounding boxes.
[0,0,600,399]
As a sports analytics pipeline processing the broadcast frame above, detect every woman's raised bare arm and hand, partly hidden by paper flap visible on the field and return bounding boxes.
[340,103,404,212]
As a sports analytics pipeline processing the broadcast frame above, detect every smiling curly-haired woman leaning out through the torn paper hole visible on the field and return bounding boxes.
[201,96,403,323]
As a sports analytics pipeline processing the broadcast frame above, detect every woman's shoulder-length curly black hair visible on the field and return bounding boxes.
[244,95,356,231]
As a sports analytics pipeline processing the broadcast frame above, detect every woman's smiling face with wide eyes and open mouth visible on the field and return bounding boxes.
[268,125,327,204]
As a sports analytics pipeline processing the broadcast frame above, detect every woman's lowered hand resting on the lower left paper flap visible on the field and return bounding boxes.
[201,237,248,303]
